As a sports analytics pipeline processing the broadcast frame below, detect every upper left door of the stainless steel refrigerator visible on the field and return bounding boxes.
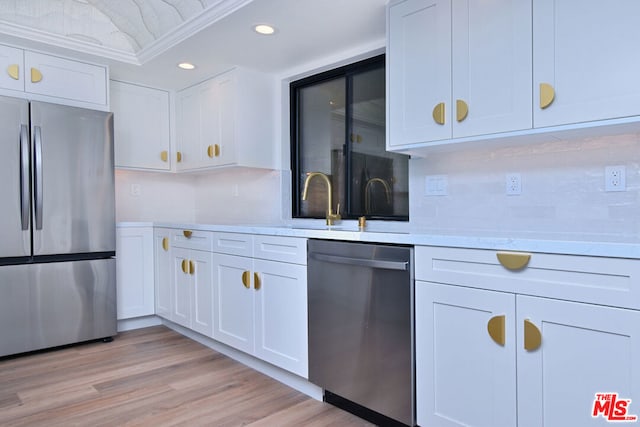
[0,97,31,258]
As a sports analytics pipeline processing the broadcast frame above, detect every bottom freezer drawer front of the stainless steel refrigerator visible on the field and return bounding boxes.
[0,258,117,356]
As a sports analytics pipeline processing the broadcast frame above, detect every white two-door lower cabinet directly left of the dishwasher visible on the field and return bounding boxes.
[213,236,308,378]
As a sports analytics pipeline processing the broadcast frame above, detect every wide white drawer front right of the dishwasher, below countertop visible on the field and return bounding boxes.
[415,246,640,309]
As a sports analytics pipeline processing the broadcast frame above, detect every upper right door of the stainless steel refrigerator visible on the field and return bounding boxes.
[31,102,116,256]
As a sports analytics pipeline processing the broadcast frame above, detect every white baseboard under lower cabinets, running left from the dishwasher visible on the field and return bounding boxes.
[160,319,322,400]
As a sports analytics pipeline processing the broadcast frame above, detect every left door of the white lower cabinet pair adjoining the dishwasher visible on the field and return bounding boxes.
[213,254,255,354]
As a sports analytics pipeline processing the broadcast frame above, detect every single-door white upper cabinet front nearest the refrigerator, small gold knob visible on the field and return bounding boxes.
[111,81,171,170]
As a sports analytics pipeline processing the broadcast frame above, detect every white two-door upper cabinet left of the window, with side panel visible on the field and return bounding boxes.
[176,68,275,171]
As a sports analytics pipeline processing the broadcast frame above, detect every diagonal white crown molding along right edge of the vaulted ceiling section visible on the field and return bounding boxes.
[137,0,253,64]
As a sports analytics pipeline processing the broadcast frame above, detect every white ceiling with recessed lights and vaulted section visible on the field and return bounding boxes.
[0,0,386,89]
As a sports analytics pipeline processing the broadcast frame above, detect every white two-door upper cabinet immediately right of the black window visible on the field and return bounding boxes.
[387,0,532,148]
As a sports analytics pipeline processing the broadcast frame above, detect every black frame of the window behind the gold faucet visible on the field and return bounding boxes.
[289,54,409,222]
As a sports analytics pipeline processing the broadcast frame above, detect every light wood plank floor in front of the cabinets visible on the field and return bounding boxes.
[0,326,370,427]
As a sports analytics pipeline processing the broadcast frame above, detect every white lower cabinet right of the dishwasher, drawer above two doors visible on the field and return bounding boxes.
[416,248,640,427]
